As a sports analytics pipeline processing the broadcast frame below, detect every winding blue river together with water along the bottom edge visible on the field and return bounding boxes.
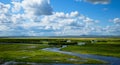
[0,48,120,65]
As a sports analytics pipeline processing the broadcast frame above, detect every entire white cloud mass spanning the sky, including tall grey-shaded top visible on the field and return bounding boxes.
[0,0,120,36]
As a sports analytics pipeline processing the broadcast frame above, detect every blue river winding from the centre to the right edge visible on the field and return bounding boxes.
[42,48,120,65]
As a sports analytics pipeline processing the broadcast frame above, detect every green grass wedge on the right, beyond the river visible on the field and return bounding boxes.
[62,42,120,57]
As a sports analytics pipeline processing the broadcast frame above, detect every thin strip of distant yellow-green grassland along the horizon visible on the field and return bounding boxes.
[0,38,120,44]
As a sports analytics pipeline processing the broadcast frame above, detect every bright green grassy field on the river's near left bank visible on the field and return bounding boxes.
[0,44,104,64]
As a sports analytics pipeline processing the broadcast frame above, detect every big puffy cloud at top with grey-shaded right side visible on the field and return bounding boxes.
[22,0,52,16]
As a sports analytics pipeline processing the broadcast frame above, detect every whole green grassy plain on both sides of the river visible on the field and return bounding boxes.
[0,38,120,64]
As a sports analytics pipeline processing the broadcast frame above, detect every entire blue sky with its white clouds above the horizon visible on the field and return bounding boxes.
[0,0,120,36]
